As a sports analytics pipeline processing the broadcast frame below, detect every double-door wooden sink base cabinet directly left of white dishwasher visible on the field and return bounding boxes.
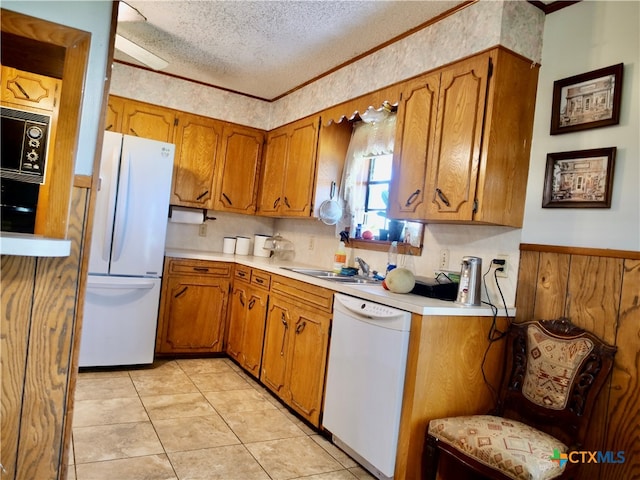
[260,277,333,426]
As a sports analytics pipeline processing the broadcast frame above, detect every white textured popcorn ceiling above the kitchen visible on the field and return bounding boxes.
[115,0,466,99]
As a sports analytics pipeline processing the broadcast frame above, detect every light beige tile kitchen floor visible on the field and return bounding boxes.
[67,358,374,480]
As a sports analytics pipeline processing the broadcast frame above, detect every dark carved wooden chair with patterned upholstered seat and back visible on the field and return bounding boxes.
[423,318,616,480]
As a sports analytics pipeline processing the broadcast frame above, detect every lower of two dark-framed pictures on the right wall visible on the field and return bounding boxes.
[542,147,616,208]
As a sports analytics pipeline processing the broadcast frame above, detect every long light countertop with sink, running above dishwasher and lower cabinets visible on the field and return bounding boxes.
[165,248,515,317]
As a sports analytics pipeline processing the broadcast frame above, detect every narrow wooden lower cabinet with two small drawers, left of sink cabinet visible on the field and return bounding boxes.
[226,265,270,378]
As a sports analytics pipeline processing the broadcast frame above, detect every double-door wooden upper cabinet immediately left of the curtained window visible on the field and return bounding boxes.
[258,116,320,217]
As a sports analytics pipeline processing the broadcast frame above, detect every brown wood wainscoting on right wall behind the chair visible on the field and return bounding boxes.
[516,245,640,480]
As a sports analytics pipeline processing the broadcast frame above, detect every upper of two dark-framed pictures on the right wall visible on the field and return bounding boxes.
[551,63,623,135]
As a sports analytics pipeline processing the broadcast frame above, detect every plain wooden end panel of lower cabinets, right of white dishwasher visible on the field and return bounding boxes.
[394,314,507,480]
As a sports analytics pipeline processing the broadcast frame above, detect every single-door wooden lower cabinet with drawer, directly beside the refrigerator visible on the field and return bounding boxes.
[156,258,233,355]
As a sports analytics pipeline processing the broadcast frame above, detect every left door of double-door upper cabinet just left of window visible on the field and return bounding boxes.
[258,128,288,215]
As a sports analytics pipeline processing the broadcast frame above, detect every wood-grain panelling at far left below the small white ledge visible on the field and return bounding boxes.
[1,188,88,480]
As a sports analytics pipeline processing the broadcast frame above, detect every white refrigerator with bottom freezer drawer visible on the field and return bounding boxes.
[79,132,175,367]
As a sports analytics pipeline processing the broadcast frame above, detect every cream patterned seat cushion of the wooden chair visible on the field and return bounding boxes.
[429,415,567,480]
